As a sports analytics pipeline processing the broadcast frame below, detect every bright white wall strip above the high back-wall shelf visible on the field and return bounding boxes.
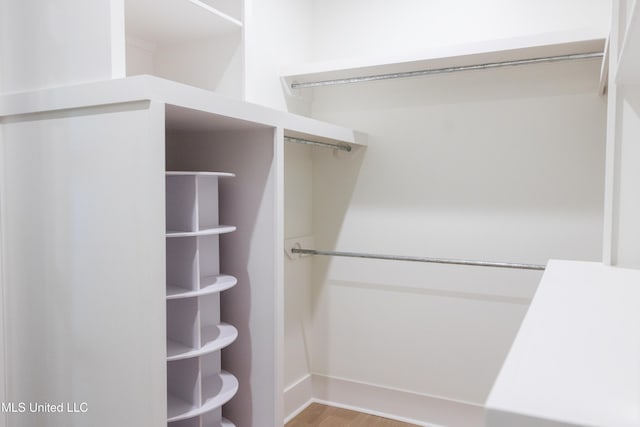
[312,0,611,61]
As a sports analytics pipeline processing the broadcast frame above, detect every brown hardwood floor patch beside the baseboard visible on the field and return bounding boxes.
[285,403,416,427]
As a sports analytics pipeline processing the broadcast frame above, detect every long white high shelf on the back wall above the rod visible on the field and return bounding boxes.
[281,29,606,87]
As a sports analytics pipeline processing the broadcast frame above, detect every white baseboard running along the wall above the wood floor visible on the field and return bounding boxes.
[284,374,484,427]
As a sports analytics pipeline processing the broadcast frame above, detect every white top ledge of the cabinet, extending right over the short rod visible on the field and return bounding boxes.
[0,75,366,150]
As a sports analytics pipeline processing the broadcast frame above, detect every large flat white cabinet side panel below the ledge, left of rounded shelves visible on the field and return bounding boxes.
[0,101,166,427]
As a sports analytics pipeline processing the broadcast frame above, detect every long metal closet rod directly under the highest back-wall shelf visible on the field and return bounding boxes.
[291,52,604,89]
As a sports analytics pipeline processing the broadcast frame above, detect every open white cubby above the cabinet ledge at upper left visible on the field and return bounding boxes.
[125,0,244,98]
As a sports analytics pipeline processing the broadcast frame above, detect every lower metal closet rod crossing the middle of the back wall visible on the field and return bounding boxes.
[291,248,545,270]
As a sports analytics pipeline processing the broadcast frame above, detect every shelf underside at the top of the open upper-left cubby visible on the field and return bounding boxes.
[125,0,242,45]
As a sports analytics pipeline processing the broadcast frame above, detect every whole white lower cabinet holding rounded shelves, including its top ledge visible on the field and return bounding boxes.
[0,76,360,427]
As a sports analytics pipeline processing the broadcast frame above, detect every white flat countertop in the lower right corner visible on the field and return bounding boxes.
[486,260,640,427]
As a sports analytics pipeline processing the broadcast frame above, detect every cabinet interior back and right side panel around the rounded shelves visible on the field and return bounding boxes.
[167,128,283,427]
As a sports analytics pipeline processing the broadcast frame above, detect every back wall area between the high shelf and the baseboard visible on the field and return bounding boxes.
[311,61,605,404]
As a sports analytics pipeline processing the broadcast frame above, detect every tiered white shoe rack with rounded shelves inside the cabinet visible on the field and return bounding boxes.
[165,172,238,427]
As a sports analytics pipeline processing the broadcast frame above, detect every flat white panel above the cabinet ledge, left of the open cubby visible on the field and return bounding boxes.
[0,0,122,93]
